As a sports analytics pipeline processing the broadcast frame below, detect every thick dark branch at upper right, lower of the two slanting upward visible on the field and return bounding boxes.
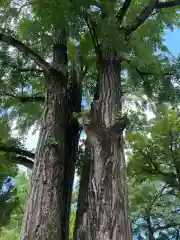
[124,0,158,35]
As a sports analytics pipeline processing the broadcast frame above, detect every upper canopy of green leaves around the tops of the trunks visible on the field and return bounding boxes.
[0,0,180,139]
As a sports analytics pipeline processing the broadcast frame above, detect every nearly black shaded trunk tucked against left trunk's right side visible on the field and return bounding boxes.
[62,72,82,240]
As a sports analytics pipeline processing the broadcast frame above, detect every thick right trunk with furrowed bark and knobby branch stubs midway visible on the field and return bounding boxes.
[85,56,131,240]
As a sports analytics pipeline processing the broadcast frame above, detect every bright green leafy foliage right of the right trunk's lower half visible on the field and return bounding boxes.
[126,104,180,239]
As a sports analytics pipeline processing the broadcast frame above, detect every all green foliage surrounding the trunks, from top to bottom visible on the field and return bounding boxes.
[0,0,180,239]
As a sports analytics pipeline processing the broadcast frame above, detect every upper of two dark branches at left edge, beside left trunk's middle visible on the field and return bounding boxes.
[0,143,35,159]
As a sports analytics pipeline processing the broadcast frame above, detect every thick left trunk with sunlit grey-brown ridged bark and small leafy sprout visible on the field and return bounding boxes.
[21,74,68,240]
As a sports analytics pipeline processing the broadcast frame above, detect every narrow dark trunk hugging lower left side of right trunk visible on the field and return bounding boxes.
[73,139,92,240]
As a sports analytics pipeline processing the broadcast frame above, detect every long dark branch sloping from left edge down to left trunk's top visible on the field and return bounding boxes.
[0,33,65,81]
